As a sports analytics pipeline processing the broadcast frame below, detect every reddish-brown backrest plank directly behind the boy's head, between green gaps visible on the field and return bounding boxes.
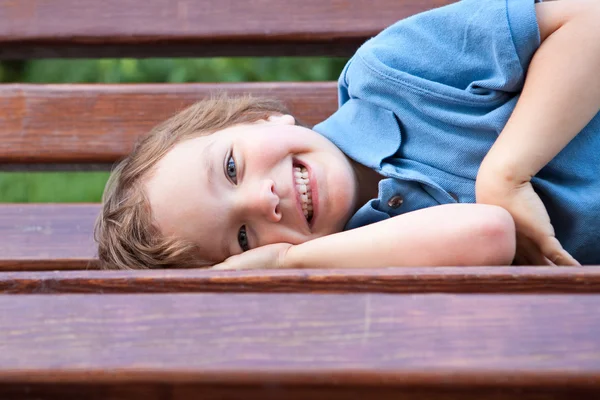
[0,83,337,166]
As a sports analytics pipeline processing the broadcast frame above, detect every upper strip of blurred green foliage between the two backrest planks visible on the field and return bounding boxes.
[0,57,347,83]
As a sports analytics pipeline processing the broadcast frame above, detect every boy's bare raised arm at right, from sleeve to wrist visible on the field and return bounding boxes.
[477,1,600,189]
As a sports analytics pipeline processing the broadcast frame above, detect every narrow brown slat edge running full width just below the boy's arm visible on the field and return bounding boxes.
[0,267,600,294]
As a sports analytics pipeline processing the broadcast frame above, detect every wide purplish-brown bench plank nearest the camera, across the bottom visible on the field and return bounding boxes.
[0,294,600,399]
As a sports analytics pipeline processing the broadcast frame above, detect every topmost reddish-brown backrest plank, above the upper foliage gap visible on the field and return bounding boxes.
[0,0,452,59]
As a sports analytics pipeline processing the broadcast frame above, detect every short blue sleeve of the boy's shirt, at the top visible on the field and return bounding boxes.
[352,0,540,95]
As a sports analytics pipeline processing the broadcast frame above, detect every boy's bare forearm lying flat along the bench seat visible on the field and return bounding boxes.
[282,204,514,268]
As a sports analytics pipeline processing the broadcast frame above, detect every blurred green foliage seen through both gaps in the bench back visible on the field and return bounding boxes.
[0,57,347,203]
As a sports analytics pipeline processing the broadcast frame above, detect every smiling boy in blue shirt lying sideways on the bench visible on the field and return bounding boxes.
[96,0,600,269]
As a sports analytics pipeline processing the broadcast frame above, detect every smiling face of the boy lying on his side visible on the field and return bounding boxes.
[146,115,357,262]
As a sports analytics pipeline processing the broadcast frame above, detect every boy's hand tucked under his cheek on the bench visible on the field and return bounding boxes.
[211,243,292,270]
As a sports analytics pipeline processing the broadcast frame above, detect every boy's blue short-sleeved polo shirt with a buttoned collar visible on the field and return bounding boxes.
[314,0,600,264]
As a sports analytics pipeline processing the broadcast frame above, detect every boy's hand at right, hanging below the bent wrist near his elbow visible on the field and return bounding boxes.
[477,182,581,266]
